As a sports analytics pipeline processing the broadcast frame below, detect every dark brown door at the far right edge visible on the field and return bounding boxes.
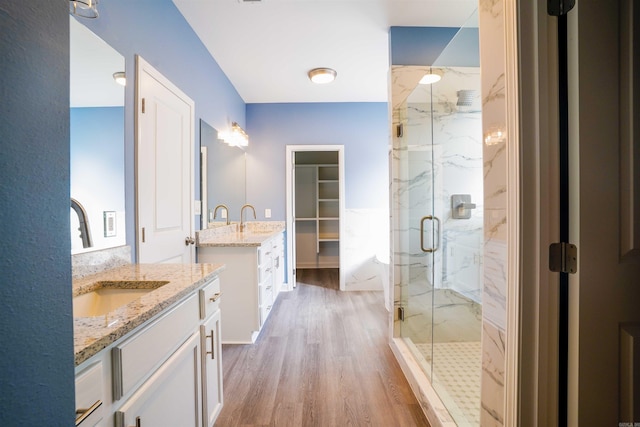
[568,0,640,426]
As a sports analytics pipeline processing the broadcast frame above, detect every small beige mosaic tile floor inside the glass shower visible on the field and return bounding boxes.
[414,341,482,426]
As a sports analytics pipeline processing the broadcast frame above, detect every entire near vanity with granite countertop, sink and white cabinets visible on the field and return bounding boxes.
[73,264,224,427]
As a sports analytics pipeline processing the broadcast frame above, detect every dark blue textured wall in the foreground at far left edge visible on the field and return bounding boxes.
[0,0,75,426]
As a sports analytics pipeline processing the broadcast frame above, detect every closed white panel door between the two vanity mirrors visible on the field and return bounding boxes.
[136,56,195,263]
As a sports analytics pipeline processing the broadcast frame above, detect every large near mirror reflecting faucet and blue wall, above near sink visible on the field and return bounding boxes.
[69,16,126,254]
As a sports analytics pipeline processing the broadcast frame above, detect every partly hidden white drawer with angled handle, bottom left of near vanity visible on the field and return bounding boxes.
[76,362,105,427]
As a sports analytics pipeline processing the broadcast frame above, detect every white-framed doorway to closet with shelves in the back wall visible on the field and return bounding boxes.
[286,145,345,290]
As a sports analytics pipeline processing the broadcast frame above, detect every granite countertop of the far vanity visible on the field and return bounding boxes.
[196,221,285,247]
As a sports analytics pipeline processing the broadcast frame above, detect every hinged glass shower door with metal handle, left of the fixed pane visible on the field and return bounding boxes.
[396,75,440,378]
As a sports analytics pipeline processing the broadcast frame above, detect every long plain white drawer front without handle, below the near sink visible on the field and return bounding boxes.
[112,294,199,400]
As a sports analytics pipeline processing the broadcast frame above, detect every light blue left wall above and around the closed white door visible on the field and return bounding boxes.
[81,0,245,253]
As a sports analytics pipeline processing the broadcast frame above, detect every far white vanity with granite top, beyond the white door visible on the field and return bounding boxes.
[196,222,285,344]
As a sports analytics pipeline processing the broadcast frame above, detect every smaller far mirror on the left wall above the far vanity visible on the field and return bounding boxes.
[200,120,246,228]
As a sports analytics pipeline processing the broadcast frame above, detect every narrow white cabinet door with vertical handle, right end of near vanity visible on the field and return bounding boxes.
[200,310,222,427]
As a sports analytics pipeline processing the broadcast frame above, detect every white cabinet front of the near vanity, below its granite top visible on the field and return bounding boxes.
[76,277,222,427]
